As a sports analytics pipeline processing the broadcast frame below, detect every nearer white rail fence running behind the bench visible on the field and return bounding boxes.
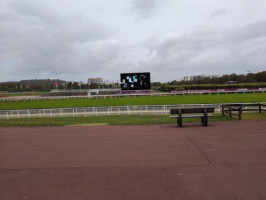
[0,104,220,119]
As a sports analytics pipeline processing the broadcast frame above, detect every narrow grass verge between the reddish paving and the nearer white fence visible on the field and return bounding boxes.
[0,113,266,127]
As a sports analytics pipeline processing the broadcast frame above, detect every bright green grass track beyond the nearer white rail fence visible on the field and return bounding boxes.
[0,93,266,110]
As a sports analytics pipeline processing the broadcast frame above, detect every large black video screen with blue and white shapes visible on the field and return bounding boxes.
[120,72,151,90]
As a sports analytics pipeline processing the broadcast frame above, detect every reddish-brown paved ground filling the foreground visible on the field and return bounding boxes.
[0,120,266,200]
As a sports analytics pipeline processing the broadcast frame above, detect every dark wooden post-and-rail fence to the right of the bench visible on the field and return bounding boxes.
[221,103,266,120]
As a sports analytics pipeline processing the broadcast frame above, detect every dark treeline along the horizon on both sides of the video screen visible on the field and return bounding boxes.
[0,71,266,92]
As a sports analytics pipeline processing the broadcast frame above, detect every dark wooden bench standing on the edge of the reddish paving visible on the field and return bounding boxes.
[170,108,214,127]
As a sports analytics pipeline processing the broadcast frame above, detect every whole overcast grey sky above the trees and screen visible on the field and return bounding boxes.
[0,0,266,82]
